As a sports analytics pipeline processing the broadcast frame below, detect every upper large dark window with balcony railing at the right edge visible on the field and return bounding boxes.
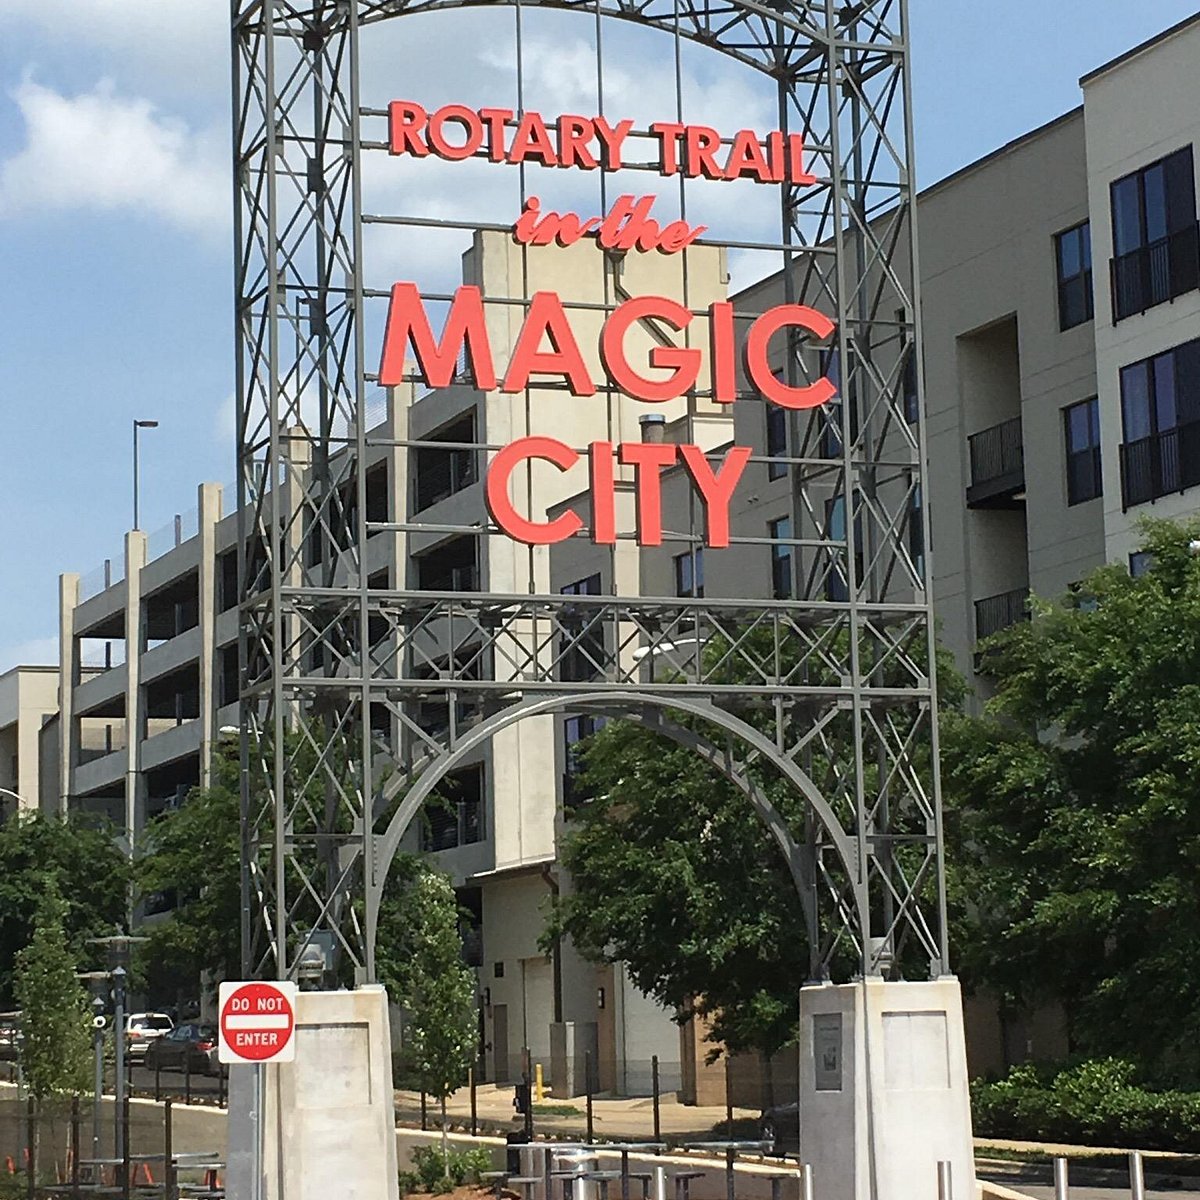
[1111,146,1200,320]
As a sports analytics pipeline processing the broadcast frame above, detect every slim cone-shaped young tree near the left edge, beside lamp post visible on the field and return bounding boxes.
[14,878,91,1105]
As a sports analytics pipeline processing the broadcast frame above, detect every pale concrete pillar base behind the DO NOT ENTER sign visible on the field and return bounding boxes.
[228,985,398,1200]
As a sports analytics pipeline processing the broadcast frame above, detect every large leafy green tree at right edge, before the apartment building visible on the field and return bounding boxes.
[943,522,1200,1082]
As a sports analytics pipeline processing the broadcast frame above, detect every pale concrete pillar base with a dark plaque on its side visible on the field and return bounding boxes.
[799,977,976,1200]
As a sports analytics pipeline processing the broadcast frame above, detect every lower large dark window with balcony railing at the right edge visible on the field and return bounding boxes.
[1121,340,1200,509]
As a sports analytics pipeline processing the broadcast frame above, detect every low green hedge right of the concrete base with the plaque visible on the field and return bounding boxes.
[971,1058,1200,1153]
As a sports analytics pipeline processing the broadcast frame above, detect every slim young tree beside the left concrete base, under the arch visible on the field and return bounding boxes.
[379,859,478,1162]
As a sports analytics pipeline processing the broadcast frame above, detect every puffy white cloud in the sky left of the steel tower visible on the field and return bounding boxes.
[0,79,232,239]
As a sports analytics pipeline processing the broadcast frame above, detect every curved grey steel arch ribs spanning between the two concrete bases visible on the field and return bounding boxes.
[366,691,869,978]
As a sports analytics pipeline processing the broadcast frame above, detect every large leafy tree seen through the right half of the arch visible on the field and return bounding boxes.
[544,630,964,1055]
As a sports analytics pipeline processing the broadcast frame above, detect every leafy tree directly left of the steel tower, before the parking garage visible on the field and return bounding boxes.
[137,740,241,995]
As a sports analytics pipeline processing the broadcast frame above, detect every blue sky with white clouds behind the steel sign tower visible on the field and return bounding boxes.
[0,0,1196,671]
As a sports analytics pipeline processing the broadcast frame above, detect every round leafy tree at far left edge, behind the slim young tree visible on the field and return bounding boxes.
[0,814,130,1008]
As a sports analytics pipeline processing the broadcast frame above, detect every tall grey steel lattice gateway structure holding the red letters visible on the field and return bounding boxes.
[232,0,947,979]
